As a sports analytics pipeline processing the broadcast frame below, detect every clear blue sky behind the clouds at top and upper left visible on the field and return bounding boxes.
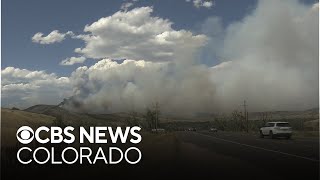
[2,0,262,75]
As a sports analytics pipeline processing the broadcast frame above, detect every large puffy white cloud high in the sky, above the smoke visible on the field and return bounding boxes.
[75,7,206,61]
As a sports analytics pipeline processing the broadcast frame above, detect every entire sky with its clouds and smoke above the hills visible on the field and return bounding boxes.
[1,0,319,112]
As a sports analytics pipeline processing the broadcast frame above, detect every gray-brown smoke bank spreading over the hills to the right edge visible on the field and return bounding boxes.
[63,0,319,113]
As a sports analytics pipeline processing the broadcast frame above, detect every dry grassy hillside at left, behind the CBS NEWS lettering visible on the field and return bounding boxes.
[1,105,129,146]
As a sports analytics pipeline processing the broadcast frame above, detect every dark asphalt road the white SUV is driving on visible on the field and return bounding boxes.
[176,132,319,180]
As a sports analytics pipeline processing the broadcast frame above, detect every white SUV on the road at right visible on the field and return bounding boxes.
[260,122,292,139]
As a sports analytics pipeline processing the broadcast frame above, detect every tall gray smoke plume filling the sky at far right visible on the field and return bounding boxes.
[212,0,319,110]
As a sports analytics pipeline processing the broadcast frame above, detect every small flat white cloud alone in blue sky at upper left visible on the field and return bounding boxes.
[31,30,73,44]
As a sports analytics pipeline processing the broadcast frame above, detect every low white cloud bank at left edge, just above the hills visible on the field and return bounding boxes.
[1,67,72,108]
